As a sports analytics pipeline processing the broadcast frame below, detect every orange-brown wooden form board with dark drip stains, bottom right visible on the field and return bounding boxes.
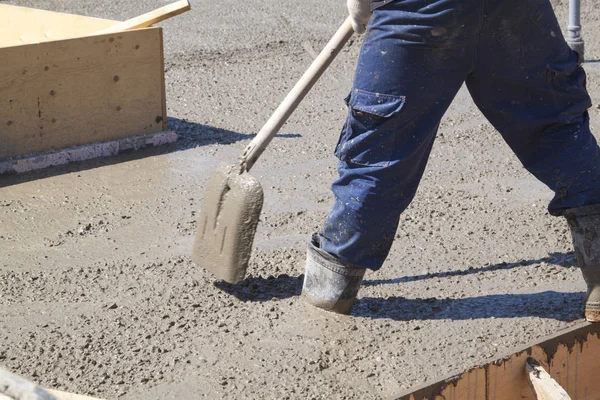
[394,323,600,400]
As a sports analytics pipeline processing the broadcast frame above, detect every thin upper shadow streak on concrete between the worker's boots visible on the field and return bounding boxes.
[363,251,577,286]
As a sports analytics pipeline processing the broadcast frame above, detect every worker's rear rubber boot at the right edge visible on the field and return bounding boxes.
[565,205,600,322]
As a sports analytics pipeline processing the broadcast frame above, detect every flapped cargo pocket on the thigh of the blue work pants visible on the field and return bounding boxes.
[335,89,405,167]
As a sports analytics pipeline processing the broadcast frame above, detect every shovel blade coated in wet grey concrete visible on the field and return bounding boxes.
[192,165,263,283]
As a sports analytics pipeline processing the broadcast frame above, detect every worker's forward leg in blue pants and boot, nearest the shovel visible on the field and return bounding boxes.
[304,0,481,312]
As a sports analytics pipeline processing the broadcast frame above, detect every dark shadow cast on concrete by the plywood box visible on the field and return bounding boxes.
[0,118,301,188]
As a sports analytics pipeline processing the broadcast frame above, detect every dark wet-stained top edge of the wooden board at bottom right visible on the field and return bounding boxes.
[390,322,600,400]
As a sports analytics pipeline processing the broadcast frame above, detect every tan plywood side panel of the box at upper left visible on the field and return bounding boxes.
[0,28,166,158]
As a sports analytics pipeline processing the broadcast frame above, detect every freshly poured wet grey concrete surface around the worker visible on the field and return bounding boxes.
[0,0,600,399]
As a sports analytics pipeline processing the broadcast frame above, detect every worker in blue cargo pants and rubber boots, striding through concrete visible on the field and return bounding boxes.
[302,0,600,321]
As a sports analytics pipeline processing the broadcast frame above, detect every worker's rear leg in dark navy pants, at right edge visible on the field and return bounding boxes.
[467,0,600,320]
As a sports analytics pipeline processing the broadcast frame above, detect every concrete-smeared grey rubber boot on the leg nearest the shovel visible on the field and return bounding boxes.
[302,235,365,314]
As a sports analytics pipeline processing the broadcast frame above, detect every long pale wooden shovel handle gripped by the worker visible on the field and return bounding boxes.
[240,17,354,172]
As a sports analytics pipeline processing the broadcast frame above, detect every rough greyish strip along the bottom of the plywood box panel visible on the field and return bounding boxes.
[0,131,178,175]
